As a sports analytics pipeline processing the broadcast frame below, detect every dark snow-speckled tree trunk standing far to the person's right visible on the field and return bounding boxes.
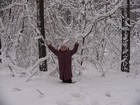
[121,0,130,72]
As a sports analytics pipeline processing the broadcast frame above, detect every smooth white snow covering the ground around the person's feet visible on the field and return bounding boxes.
[0,65,140,105]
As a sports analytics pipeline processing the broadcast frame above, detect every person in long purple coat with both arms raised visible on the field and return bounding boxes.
[46,42,79,83]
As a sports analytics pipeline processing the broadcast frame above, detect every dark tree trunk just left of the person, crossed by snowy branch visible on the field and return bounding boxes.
[36,0,47,71]
